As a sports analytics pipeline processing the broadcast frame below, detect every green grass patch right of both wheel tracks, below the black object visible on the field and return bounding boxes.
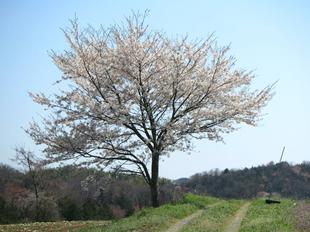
[240,199,296,232]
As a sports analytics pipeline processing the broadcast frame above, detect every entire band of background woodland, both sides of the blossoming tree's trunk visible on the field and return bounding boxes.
[0,162,310,224]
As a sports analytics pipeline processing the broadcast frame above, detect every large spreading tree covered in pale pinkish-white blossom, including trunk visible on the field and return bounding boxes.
[27,11,272,206]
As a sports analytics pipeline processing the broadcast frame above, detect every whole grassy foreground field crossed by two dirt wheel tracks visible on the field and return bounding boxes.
[0,194,310,232]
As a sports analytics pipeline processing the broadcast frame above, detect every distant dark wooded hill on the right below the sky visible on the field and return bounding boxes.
[176,162,310,198]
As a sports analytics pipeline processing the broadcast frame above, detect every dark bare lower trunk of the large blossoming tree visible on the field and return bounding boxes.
[150,153,159,207]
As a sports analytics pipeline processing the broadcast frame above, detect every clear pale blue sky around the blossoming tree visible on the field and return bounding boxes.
[0,0,310,178]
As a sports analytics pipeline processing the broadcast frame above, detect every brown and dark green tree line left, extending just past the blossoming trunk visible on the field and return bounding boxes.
[0,164,180,224]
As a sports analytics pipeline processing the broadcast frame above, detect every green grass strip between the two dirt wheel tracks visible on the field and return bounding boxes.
[181,200,244,232]
